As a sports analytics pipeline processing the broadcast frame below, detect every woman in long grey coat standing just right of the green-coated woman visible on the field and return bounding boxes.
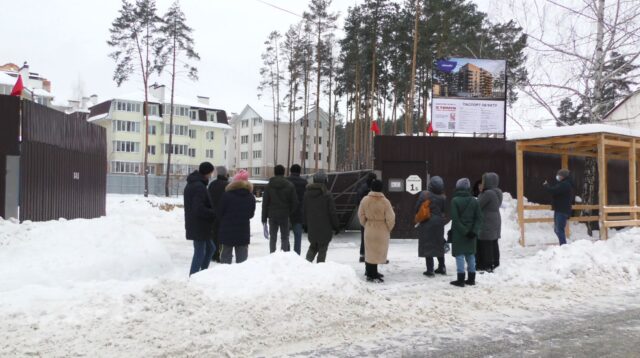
[476,173,502,272]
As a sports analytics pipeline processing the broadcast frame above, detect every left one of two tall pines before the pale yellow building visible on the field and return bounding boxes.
[107,0,160,197]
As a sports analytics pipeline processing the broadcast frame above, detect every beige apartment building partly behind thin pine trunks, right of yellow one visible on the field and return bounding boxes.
[227,105,335,179]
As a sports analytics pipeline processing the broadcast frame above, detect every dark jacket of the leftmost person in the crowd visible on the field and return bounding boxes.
[183,170,215,240]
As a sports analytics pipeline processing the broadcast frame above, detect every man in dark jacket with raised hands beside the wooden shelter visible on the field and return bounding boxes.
[543,169,573,245]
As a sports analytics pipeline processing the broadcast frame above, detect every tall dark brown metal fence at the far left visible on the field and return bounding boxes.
[0,96,107,221]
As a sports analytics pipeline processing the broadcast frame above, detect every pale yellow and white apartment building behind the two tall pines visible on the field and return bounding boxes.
[88,85,231,175]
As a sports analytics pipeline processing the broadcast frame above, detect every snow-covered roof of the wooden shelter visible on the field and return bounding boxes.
[507,124,640,141]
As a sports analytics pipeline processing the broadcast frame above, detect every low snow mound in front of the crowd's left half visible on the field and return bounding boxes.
[191,252,362,302]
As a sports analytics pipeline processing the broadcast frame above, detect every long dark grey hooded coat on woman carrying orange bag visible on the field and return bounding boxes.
[415,191,447,257]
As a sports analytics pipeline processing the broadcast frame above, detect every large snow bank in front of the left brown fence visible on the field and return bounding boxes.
[0,218,173,291]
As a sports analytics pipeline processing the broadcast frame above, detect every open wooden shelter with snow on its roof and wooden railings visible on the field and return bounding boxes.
[509,124,640,246]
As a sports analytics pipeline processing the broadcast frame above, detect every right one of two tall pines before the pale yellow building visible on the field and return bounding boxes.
[156,1,200,196]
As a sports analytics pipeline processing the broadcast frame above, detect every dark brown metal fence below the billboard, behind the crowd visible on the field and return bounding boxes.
[374,136,628,238]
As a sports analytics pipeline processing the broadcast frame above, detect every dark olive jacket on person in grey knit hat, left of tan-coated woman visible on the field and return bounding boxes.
[303,183,339,244]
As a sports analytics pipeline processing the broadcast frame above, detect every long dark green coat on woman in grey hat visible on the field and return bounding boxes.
[451,189,482,256]
